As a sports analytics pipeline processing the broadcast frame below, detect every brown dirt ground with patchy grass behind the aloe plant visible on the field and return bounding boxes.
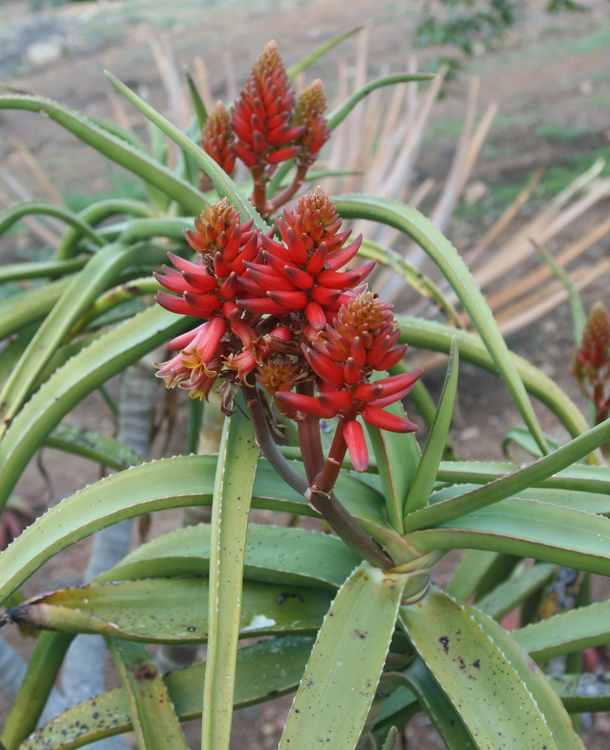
[0,0,610,750]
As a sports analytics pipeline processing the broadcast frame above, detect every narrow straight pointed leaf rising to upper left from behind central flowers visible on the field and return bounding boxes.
[106,72,268,229]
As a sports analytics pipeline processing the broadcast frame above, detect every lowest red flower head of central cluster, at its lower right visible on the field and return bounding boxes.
[276,292,421,471]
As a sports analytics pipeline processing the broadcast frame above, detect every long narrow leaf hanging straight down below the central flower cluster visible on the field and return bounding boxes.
[201,412,256,750]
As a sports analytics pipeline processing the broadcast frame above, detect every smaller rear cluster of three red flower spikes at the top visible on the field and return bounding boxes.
[202,42,329,215]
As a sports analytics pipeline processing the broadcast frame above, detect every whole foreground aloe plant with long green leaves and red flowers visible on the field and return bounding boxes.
[0,27,610,750]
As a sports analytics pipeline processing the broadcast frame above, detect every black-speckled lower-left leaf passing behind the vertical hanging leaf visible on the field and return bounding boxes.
[20,636,313,750]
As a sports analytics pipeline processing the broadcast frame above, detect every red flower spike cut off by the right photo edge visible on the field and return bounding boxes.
[572,302,610,422]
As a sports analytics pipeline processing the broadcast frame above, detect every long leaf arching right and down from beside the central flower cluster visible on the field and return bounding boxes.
[334,195,546,452]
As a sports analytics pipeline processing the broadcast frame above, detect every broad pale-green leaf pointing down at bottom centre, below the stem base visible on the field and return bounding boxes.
[279,563,404,750]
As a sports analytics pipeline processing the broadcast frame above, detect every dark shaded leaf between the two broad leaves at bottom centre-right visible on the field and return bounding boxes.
[404,659,477,750]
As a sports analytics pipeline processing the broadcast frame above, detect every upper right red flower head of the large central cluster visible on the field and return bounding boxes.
[238,188,375,330]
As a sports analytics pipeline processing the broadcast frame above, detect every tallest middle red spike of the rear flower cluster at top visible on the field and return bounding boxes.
[232,42,303,169]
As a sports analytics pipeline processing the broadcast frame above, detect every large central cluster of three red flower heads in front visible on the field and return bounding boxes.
[157,188,419,476]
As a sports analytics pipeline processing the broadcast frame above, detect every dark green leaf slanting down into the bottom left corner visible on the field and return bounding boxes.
[0,632,72,750]
